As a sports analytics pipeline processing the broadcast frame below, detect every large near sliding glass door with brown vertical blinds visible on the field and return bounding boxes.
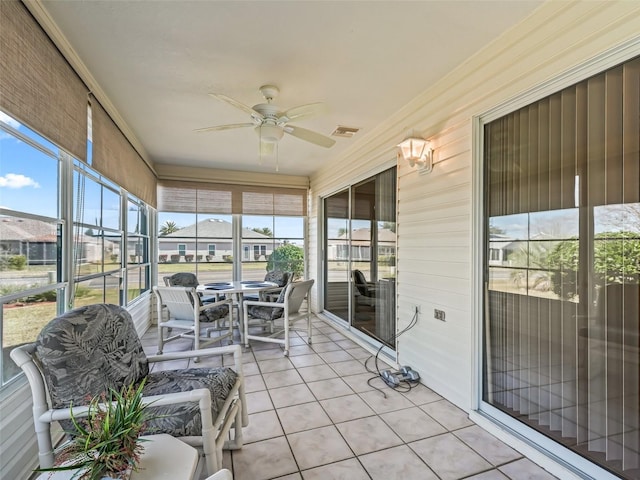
[483,55,640,478]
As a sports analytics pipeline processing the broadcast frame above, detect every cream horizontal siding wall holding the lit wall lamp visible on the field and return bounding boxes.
[309,2,640,432]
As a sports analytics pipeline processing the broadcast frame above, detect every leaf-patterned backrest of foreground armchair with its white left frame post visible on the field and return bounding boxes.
[11,304,149,467]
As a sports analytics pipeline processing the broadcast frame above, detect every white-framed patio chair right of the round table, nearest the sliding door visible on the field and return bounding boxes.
[243,280,314,356]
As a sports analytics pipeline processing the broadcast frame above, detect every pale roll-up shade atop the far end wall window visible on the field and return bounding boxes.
[158,180,307,216]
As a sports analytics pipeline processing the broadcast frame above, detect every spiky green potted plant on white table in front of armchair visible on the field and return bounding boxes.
[36,381,150,480]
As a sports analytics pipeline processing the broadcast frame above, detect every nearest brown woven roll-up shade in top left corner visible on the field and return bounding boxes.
[0,0,89,161]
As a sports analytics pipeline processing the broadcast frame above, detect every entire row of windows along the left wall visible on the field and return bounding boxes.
[0,108,150,385]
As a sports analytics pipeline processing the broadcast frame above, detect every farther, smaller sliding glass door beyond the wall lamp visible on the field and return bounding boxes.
[324,167,396,347]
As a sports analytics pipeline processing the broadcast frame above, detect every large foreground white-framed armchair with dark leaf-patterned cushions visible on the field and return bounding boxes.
[11,304,248,474]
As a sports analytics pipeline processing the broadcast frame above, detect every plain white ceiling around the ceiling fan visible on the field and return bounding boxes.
[41,0,542,176]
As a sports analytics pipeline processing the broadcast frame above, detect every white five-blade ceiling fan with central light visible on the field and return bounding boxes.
[195,85,336,155]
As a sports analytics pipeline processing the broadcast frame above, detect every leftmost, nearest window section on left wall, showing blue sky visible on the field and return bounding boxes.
[0,111,63,386]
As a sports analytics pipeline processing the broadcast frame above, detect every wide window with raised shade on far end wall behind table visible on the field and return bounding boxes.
[158,181,307,283]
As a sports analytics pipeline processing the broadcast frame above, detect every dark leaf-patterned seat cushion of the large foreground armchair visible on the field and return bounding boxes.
[144,367,237,437]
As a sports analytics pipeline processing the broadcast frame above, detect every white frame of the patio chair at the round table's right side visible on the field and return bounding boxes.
[243,280,314,356]
